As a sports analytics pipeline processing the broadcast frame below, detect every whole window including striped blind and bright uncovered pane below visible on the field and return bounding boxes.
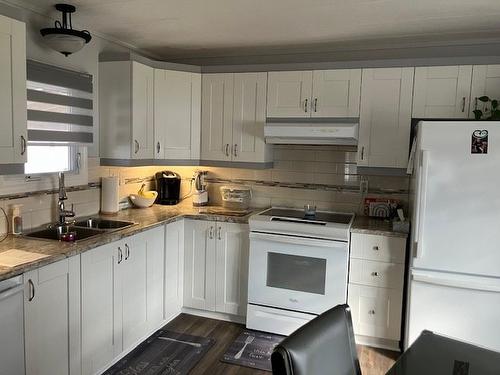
[25,61,93,175]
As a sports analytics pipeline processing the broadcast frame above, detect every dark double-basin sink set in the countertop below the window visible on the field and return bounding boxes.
[24,218,135,242]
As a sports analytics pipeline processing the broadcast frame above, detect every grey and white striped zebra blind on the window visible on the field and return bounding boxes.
[27,60,93,145]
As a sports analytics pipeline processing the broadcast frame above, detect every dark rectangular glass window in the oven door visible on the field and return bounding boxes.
[266,252,326,295]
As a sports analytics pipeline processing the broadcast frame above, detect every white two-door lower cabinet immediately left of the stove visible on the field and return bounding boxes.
[184,220,249,316]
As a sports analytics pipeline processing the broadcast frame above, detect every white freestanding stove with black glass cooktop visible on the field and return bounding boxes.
[247,208,354,335]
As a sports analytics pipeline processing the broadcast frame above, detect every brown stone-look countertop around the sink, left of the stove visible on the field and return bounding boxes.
[0,200,261,281]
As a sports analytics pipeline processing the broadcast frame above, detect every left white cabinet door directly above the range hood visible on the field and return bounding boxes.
[267,71,312,117]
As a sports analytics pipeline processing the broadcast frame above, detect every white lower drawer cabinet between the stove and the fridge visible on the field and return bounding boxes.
[348,233,406,349]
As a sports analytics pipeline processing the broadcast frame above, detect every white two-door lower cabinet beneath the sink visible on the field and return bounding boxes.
[81,227,165,374]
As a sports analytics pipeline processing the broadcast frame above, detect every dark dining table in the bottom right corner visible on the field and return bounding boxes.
[386,331,500,375]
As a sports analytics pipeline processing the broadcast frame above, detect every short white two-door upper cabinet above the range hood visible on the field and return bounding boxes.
[267,69,361,118]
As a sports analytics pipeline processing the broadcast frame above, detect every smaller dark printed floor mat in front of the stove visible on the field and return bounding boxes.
[221,330,285,371]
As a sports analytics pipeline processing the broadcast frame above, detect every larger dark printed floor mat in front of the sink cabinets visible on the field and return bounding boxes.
[104,330,215,375]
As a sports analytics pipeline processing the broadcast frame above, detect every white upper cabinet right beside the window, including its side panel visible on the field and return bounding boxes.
[99,61,154,159]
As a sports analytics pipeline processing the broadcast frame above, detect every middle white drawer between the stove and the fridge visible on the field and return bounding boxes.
[349,259,404,289]
